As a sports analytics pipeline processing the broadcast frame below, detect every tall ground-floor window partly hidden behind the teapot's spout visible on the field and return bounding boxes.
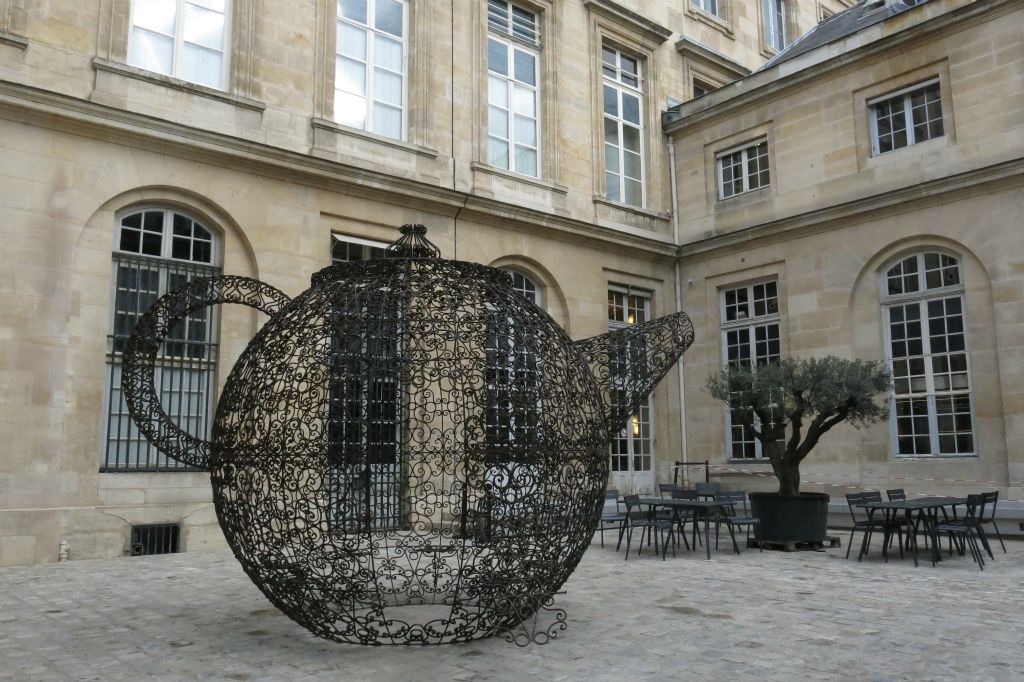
[608,287,654,473]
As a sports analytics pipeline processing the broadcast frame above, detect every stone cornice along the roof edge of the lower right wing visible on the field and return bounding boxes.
[662,0,1020,135]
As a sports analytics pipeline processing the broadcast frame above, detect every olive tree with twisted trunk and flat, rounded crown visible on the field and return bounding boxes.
[708,355,892,495]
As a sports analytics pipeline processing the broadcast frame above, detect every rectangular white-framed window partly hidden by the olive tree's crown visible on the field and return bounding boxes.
[722,281,781,460]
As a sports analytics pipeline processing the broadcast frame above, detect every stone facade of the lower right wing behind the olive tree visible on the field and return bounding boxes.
[665,0,1024,499]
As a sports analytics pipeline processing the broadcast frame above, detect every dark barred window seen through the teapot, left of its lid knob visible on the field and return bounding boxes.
[328,235,404,532]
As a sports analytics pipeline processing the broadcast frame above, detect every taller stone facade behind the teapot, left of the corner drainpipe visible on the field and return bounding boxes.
[0,0,851,565]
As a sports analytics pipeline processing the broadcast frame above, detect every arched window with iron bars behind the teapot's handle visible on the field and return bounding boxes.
[100,207,220,471]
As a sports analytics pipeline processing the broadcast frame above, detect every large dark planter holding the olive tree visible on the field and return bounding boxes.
[751,493,828,545]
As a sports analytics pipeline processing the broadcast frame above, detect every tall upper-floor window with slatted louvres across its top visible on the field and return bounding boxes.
[487,0,541,177]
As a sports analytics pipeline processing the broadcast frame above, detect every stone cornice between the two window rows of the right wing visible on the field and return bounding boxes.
[678,159,1024,263]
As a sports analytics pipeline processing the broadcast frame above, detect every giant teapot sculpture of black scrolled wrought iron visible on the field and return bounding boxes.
[123,225,693,644]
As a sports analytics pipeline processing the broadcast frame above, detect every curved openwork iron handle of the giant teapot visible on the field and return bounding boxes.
[121,275,291,469]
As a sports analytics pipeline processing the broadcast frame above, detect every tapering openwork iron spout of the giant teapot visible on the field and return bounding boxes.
[574,312,693,432]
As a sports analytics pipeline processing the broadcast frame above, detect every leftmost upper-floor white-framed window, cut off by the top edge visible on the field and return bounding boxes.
[128,0,230,90]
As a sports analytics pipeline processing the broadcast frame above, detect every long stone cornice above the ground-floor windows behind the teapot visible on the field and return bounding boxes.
[0,80,675,258]
